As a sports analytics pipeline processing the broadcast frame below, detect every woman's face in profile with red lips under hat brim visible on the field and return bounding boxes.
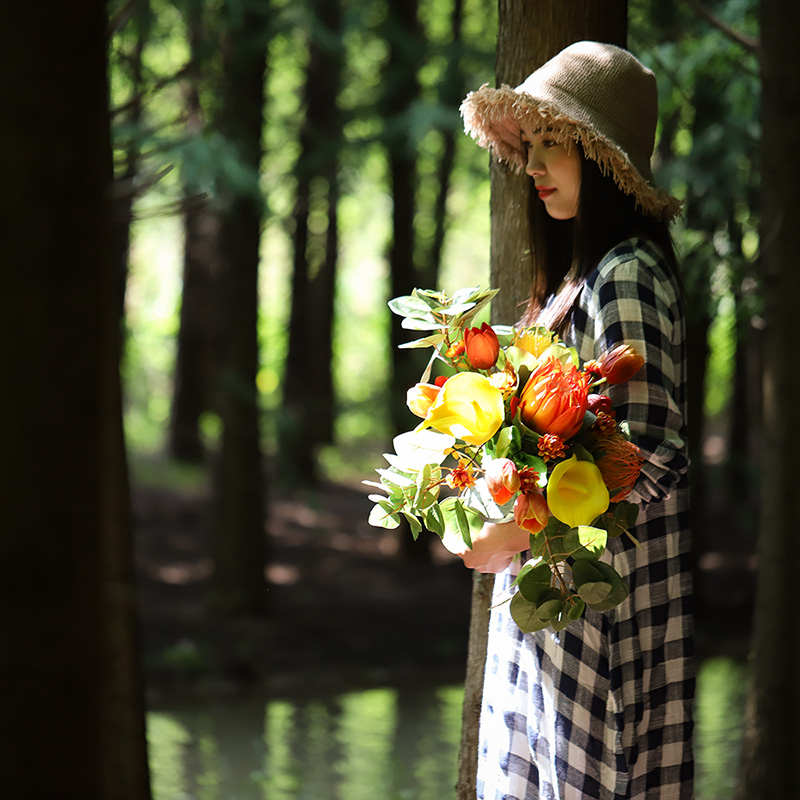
[522,128,581,219]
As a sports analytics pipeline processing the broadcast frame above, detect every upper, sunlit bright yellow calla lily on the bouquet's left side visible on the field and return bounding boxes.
[422,372,505,447]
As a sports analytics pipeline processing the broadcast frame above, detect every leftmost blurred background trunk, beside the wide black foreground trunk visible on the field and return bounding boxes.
[169,7,220,463]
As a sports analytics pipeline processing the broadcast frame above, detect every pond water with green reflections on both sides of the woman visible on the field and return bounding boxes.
[148,657,745,800]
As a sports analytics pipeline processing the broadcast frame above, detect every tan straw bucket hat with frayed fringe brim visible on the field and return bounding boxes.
[461,42,680,220]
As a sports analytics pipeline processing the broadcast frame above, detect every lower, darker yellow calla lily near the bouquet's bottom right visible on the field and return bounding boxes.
[547,456,608,528]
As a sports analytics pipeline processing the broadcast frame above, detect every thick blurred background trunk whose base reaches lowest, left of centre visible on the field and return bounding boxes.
[214,0,268,613]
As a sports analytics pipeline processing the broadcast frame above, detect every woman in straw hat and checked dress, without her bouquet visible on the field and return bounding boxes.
[462,42,694,800]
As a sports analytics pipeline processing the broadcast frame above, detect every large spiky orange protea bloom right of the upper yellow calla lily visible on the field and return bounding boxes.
[520,358,590,440]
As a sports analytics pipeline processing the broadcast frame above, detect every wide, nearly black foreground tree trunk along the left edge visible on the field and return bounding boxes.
[0,0,150,800]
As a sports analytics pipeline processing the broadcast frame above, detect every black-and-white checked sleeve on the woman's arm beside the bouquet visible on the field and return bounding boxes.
[576,248,689,503]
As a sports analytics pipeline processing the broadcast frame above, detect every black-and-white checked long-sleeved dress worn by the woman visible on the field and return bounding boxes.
[477,239,694,800]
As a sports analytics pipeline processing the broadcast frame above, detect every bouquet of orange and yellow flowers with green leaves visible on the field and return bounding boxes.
[365,288,644,633]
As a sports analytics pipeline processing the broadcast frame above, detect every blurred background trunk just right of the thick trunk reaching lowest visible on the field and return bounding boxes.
[280,0,342,483]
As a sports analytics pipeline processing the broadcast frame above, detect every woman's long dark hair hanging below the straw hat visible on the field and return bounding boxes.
[522,145,677,333]
